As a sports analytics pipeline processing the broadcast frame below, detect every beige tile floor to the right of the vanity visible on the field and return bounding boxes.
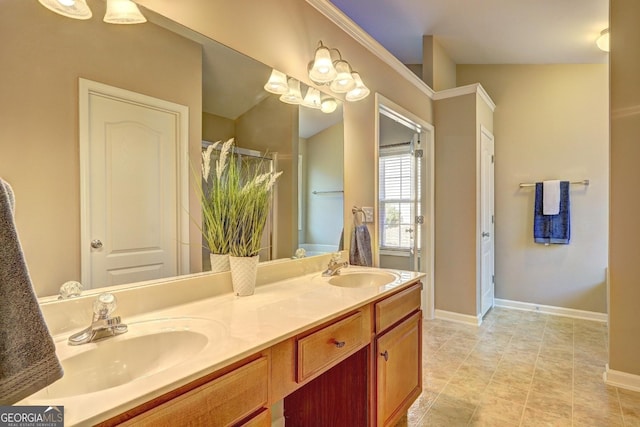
[399,308,640,427]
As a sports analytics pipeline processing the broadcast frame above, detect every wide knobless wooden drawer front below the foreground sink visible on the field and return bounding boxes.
[121,357,269,427]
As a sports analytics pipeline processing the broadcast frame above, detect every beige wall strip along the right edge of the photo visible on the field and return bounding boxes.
[609,0,640,375]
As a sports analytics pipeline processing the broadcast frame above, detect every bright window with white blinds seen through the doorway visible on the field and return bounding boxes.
[378,143,420,250]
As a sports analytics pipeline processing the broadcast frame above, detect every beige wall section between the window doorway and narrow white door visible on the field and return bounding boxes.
[434,93,479,316]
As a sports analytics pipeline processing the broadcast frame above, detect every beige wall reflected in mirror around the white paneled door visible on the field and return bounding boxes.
[0,0,202,295]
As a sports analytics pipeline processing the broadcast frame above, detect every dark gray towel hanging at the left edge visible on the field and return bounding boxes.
[0,179,63,405]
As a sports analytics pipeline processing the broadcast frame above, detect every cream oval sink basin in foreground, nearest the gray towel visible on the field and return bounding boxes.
[30,318,226,400]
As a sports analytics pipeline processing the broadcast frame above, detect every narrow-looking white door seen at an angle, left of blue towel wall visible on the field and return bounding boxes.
[480,127,495,316]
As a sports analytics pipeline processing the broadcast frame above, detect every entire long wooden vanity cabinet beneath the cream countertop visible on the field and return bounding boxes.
[99,281,422,427]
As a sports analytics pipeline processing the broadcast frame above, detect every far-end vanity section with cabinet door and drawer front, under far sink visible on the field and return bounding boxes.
[375,283,422,426]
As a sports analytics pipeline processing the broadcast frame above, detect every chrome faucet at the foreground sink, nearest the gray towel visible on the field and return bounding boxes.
[68,293,127,345]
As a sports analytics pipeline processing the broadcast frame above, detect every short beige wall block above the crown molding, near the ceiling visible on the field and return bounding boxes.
[422,36,456,91]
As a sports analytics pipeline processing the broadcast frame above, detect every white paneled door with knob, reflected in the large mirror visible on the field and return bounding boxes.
[81,81,187,288]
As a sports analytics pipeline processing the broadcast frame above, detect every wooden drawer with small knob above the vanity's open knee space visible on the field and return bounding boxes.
[296,311,369,383]
